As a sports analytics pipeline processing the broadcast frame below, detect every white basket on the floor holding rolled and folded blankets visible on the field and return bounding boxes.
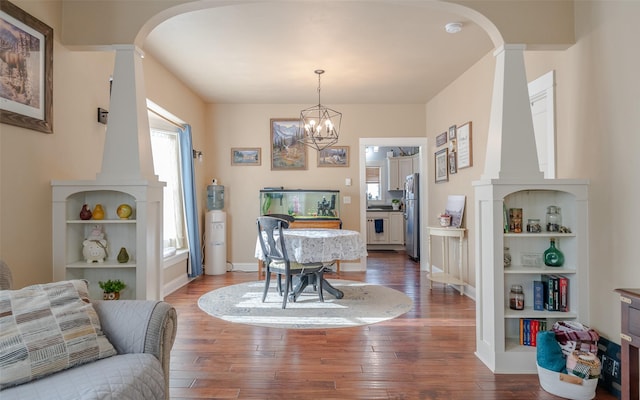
[538,365,598,400]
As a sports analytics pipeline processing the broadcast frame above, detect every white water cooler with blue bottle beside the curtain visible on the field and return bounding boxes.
[204,180,227,275]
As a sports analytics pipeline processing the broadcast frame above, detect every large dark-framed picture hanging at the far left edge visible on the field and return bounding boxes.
[0,0,53,133]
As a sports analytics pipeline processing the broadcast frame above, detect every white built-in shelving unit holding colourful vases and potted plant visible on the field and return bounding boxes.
[52,181,162,299]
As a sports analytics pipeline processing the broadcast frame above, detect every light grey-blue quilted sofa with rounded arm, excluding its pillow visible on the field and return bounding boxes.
[0,263,177,400]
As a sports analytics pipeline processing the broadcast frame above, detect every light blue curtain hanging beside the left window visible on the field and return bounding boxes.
[179,125,202,278]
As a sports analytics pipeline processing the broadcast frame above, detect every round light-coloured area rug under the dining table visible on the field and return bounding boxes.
[198,279,413,329]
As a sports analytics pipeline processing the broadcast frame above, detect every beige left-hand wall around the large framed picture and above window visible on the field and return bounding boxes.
[0,1,206,287]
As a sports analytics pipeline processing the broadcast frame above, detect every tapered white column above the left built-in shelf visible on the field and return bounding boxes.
[96,45,158,182]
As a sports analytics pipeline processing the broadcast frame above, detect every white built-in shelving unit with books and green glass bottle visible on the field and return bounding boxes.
[474,179,589,373]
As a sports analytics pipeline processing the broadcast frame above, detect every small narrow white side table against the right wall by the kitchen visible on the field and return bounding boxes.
[427,226,467,296]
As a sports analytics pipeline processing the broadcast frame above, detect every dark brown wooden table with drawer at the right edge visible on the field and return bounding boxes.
[616,289,640,400]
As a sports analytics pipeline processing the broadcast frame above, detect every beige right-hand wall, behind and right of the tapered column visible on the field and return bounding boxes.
[427,1,640,342]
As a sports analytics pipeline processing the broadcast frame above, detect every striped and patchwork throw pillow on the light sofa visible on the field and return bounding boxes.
[0,280,116,390]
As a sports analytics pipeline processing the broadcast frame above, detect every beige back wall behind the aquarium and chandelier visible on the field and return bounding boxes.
[209,104,425,265]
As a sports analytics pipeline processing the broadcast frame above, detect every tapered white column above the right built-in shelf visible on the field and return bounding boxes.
[482,44,544,180]
